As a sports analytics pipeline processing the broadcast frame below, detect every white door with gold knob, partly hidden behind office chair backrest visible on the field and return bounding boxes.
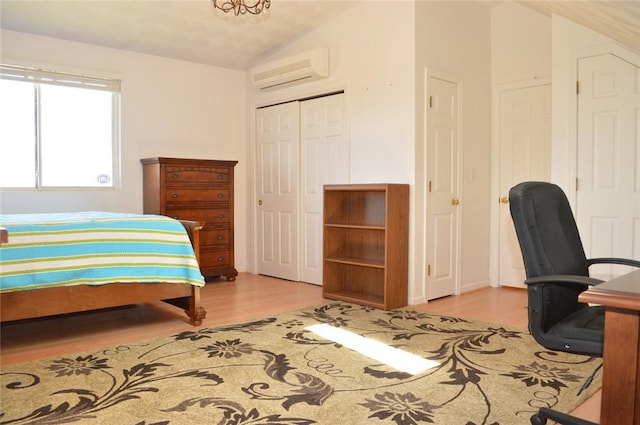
[498,84,551,288]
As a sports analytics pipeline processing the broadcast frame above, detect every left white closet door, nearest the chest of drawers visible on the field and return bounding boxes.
[256,102,300,281]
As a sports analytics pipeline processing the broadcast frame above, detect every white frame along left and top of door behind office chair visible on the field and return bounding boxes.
[489,77,553,288]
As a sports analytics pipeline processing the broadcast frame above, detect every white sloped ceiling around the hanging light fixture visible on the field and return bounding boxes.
[0,0,640,69]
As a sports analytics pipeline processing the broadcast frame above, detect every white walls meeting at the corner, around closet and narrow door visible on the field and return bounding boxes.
[248,1,491,303]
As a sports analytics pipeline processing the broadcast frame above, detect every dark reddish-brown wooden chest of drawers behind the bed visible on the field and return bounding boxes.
[141,158,238,281]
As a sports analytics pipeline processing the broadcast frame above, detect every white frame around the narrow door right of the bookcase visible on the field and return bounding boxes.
[422,67,464,303]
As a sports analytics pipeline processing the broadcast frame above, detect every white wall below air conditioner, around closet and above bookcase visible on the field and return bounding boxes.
[247,1,415,280]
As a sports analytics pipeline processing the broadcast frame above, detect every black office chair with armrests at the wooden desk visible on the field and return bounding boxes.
[509,182,640,425]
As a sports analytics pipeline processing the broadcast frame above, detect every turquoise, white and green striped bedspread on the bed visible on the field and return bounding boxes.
[0,212,204,292]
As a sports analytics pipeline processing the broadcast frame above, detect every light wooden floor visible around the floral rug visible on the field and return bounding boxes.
[0,273,600,423]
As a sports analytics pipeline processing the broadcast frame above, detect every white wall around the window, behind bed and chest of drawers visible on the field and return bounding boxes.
[0,30,248,270]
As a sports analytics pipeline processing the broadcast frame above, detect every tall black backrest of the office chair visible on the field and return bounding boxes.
[509,182,589,278]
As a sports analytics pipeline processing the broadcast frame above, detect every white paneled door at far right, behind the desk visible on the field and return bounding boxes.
[575,54,640,279]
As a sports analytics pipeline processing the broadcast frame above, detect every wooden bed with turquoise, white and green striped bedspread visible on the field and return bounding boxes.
[0,211,206,326]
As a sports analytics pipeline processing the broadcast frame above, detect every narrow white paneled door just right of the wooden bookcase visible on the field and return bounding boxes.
[426,76,459,300]
